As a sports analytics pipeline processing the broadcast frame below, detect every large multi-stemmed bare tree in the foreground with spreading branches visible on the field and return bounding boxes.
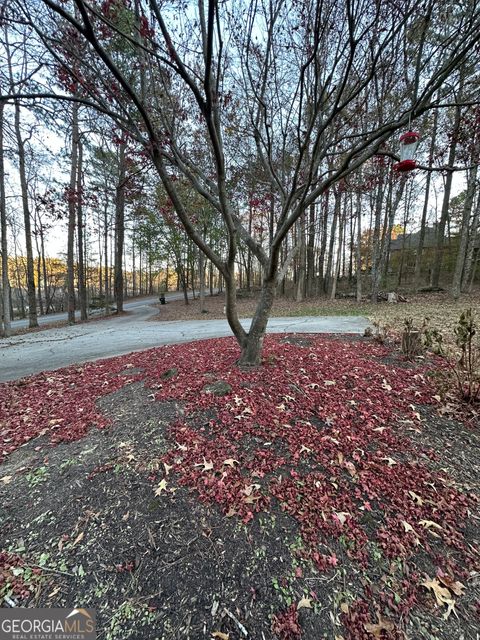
[6,0,480,365]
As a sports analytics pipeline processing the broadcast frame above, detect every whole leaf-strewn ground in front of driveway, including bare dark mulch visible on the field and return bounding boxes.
[0,335,480,640]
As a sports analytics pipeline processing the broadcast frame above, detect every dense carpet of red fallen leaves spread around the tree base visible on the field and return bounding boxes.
[0,336,473,616]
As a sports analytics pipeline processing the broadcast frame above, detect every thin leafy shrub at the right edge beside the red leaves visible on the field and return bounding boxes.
[454,309,480,403]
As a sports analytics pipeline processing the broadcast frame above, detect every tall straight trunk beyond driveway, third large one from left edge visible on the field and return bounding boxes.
[67,102,80,324]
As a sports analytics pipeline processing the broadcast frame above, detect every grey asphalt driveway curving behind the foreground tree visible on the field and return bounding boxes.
[0,294,369,382]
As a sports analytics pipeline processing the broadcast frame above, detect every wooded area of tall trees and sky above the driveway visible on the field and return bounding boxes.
[0,0,480,364]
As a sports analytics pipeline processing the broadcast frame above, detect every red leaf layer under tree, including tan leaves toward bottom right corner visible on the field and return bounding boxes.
[0,336,479,640]
